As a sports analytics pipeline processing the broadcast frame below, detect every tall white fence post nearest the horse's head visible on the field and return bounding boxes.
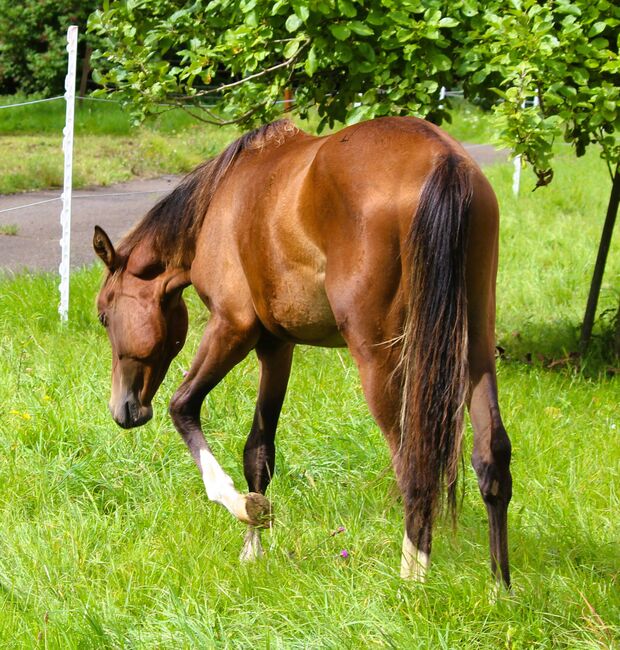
[58,25,78,322]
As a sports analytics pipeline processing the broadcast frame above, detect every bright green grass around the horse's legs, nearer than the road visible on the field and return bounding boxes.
[0,98,620,650]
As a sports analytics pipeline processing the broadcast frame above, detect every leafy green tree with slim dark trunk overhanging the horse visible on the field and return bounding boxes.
[90,0,620,350]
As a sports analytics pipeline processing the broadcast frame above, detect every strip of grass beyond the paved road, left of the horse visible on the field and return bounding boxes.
[0,97,237,194]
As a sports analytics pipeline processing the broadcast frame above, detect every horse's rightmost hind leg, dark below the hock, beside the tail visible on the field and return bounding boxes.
[469,331,512,587]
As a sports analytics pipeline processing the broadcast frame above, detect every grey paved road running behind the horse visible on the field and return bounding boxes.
[0,145,508,273]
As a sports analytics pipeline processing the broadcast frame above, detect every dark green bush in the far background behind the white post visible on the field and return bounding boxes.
[0,0,100,97]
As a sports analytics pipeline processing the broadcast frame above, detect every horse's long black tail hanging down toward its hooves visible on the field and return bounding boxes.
[399,153,472,534]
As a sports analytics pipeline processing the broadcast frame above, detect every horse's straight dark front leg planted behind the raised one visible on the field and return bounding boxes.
[240,336,294,560]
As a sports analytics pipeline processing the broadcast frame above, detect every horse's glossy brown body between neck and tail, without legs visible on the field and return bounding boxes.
[194,118,496,345]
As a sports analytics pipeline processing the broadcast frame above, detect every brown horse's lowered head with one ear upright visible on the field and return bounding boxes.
[93,226,189,429]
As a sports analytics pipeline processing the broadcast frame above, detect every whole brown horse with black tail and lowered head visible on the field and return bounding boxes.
[93,118,512,585]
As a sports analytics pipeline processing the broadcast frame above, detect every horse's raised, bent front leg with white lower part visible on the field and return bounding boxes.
[170,314,271,526]
